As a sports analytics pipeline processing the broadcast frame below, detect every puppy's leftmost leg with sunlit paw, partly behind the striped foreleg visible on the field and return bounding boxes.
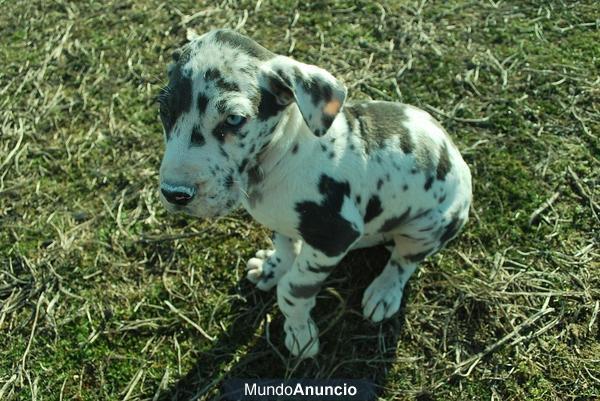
[246,233,302,291]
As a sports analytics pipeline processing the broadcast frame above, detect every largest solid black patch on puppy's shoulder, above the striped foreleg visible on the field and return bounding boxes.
[296,174,360,256]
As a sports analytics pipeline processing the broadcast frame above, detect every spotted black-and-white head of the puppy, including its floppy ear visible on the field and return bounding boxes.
[159,30,346,217]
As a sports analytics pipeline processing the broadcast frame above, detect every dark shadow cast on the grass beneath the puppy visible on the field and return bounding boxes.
[159,247,404,401]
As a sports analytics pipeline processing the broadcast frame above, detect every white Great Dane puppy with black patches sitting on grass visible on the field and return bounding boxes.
[159,30,471,357]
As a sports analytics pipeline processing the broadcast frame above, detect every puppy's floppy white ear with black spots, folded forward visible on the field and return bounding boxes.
[261,56,346,136]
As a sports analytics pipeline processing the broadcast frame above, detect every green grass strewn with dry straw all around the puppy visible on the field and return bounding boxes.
[0,0,600,401]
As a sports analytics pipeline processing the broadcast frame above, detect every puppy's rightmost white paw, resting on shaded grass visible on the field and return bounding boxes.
[362,275,403,323]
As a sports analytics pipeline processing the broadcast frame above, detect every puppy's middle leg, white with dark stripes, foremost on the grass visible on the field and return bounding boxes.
[277,236,360,358]
